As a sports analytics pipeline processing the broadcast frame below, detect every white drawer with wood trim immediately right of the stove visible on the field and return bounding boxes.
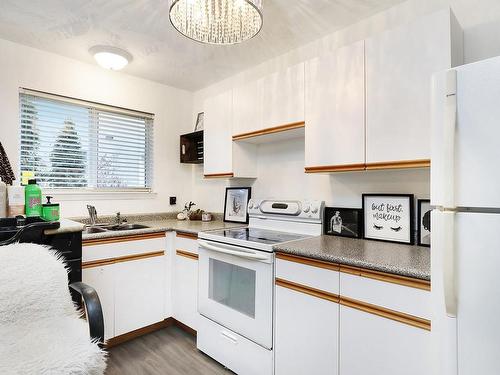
[276,253,339,295]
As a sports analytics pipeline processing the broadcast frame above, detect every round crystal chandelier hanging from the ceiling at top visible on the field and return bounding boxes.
[170,0,263,45]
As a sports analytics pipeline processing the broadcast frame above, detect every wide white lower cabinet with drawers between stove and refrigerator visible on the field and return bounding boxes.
[274,253,432,375]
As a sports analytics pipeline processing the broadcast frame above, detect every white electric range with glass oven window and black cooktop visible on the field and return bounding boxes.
[197,199,324,375]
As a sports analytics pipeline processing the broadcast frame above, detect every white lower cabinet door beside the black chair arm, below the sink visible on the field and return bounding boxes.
[82,265,115,340]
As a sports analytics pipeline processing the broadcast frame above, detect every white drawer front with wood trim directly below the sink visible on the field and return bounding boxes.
[82,233,167,263]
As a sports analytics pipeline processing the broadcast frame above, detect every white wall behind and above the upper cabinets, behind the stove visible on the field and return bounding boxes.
[189,0,500,211]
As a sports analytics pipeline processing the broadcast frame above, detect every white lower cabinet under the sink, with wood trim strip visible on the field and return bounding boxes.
[82,234,170,340]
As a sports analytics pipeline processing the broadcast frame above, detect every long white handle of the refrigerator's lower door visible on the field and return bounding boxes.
[442,212,457,317]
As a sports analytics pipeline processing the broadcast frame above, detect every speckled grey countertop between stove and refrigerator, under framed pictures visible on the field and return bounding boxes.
[274,236,431,280]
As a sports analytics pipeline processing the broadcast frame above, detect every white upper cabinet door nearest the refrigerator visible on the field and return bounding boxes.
[365,11,451,164]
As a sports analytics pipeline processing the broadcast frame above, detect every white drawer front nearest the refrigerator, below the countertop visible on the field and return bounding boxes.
[340,272,431,319]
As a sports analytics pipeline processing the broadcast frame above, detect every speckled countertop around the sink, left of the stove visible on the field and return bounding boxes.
[73,213,246,240]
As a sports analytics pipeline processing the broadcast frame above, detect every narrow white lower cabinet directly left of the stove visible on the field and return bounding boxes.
[172,236,199,330]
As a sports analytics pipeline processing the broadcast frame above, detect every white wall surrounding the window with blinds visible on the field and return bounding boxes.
[0,40,193,217]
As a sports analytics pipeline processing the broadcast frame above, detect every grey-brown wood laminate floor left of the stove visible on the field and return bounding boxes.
[106,326,233,375]
